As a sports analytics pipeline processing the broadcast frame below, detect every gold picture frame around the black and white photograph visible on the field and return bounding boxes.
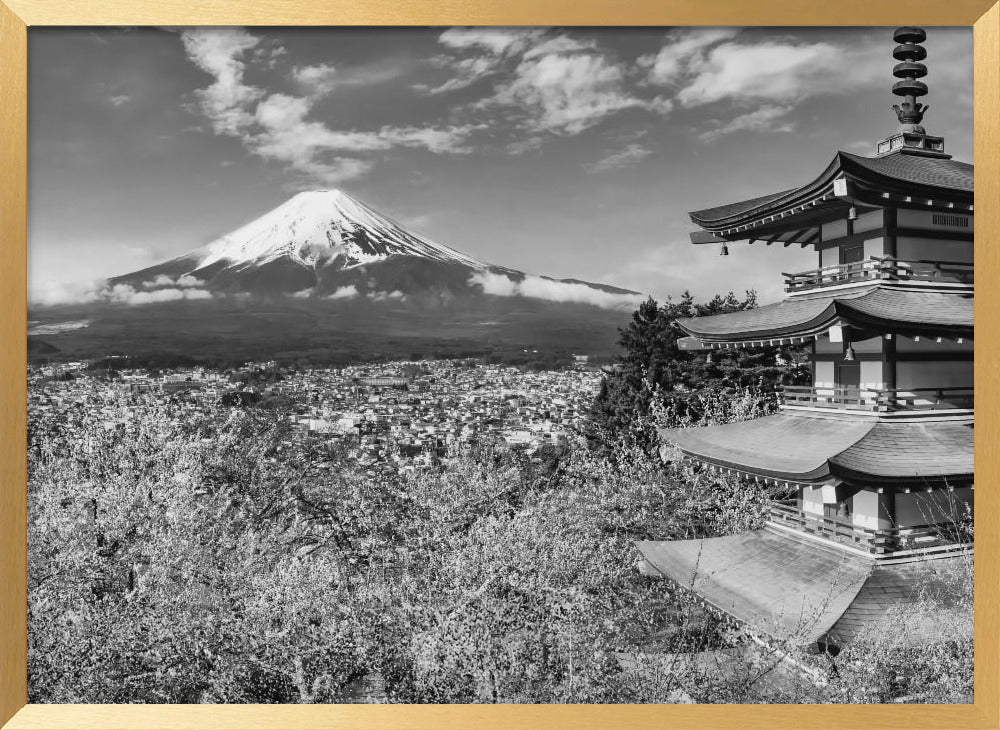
[0,0,1000,730]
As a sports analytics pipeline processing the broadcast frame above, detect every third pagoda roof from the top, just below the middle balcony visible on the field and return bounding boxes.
[660,411,974,486]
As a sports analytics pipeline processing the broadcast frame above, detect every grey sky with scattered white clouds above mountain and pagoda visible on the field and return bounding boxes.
[28,27,973,303]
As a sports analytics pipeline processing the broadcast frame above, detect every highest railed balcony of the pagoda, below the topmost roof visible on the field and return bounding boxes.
[782,256,975,294]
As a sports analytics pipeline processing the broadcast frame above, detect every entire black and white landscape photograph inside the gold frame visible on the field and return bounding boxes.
[25,26,985,705]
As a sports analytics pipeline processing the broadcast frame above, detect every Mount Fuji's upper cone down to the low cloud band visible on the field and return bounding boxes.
[109,190,640,308]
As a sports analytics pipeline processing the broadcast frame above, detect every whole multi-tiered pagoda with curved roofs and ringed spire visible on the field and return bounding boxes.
[637,27,974,650]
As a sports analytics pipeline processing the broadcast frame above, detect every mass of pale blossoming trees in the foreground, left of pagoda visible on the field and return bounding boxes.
[29,409,780,702]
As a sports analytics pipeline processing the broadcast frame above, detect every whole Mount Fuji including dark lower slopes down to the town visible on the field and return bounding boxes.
[29,190,643,363]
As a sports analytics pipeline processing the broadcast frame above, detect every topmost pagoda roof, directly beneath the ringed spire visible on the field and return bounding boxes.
[689,152,974,235]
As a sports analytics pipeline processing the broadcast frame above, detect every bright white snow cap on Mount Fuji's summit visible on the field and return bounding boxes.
[189,190,485,271]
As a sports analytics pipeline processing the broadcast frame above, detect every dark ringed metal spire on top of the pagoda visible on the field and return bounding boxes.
[877,25,951,158]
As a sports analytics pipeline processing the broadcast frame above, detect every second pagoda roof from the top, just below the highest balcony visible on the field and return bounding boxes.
[677,285,974,344]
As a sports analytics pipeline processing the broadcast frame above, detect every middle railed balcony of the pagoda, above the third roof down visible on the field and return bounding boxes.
[778,385,975,413]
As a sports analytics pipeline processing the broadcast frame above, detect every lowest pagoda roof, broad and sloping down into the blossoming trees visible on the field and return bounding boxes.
[636,529,968,646]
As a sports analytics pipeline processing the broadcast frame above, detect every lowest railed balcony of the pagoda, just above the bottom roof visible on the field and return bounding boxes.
[767,500,973,560]
